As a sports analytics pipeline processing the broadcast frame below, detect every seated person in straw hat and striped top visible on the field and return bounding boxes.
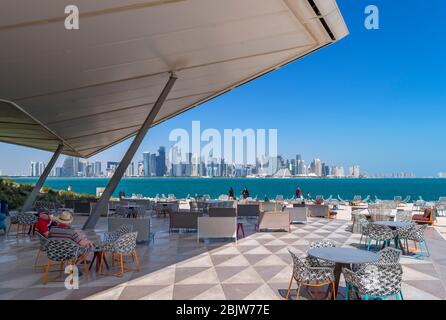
[48,211,93,253]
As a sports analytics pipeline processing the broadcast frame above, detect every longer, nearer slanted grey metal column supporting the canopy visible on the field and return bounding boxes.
[82,73,177,230]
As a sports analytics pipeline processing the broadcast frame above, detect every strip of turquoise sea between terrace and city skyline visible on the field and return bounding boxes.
[9,178,446,200]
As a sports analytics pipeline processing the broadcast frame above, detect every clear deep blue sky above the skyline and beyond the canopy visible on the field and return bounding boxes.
[0,0,446,176]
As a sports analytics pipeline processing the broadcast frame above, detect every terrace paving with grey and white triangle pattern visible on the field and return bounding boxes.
[0,218,446,300]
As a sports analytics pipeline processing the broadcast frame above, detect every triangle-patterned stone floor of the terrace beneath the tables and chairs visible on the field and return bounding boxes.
[0,204,446,300]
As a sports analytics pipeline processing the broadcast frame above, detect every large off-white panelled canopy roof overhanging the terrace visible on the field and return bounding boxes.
[0,0,348,157]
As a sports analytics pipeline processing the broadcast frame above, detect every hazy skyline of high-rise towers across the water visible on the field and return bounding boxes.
[14,146,426,178]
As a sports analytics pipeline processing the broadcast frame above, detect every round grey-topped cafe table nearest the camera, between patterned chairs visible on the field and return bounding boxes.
[308,248,379,296]
